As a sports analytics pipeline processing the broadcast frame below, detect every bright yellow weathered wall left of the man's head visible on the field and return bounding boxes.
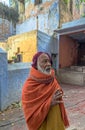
[7,30,37,62]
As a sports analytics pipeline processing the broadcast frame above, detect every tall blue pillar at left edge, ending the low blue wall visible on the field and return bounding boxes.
[0,48,8,110]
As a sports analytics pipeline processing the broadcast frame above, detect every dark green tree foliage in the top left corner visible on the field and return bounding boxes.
[0,2,19,24]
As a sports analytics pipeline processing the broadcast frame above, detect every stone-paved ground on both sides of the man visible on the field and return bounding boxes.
[0,84,85,130]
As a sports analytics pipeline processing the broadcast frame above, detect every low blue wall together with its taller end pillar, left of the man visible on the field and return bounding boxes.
[0,49,31,110]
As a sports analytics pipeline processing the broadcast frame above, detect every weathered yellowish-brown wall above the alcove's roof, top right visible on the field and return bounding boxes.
[60,0,85,22]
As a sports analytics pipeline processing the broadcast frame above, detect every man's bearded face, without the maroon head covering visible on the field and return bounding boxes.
[37,53,51,74]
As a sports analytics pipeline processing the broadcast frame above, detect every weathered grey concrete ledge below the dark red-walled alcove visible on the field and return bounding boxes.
[58,69,85,86]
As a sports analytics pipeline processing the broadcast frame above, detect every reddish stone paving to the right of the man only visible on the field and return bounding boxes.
[62,85,85,130]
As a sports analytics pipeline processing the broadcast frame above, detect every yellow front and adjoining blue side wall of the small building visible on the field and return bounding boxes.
[8,30,57,62]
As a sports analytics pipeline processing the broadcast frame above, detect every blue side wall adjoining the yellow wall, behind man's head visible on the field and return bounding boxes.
[37,31,59,70]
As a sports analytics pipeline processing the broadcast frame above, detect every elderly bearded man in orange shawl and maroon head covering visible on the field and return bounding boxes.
[22,52,69,130]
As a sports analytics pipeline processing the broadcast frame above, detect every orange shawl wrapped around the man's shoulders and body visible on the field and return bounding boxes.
[22,67,69,130]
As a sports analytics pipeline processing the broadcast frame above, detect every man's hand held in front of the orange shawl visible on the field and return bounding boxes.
[51,90,63,106]
